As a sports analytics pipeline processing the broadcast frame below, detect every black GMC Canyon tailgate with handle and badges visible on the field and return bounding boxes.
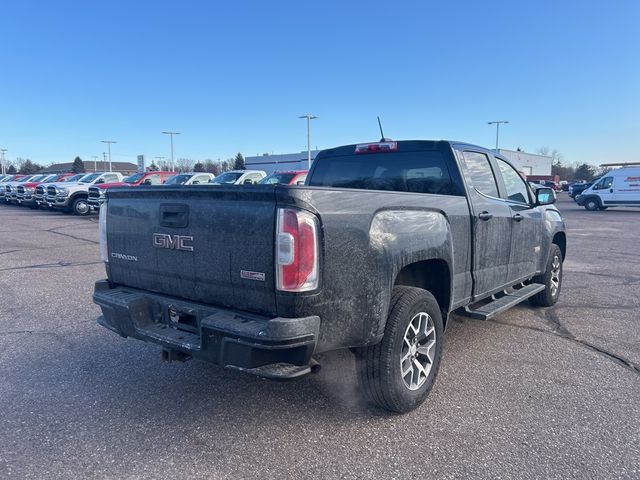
[107,186,276,315]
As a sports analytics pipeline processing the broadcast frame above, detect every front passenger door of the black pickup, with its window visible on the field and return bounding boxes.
[496,157,546,284]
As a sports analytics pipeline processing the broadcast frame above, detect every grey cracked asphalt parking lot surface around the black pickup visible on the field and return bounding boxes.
[0,193,640,478]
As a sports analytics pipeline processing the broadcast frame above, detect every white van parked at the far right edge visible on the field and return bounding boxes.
[578,165,640,211]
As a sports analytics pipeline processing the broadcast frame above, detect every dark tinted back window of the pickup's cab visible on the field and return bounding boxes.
[306,142,464,195]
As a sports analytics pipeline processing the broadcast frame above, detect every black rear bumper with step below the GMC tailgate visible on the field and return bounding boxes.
[93,280,320,369]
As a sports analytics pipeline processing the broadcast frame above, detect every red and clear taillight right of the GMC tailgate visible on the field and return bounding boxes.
[276,208,318,292]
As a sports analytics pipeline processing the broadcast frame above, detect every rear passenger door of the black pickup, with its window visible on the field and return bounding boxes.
[462,150,512,298]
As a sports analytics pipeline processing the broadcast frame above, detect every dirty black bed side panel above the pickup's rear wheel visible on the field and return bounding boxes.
[276,187,471,351]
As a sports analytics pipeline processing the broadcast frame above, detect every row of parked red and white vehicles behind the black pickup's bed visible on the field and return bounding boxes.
[0,170,307,215]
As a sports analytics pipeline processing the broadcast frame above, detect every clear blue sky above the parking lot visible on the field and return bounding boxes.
[0,0,640,164]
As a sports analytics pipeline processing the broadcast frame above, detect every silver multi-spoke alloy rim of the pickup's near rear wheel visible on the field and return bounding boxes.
[400,312,436,390]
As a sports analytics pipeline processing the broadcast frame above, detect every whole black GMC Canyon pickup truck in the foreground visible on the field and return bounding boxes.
[93,140,566,412]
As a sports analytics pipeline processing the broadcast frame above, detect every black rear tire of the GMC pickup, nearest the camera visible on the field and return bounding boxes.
[356,286,443,413]
